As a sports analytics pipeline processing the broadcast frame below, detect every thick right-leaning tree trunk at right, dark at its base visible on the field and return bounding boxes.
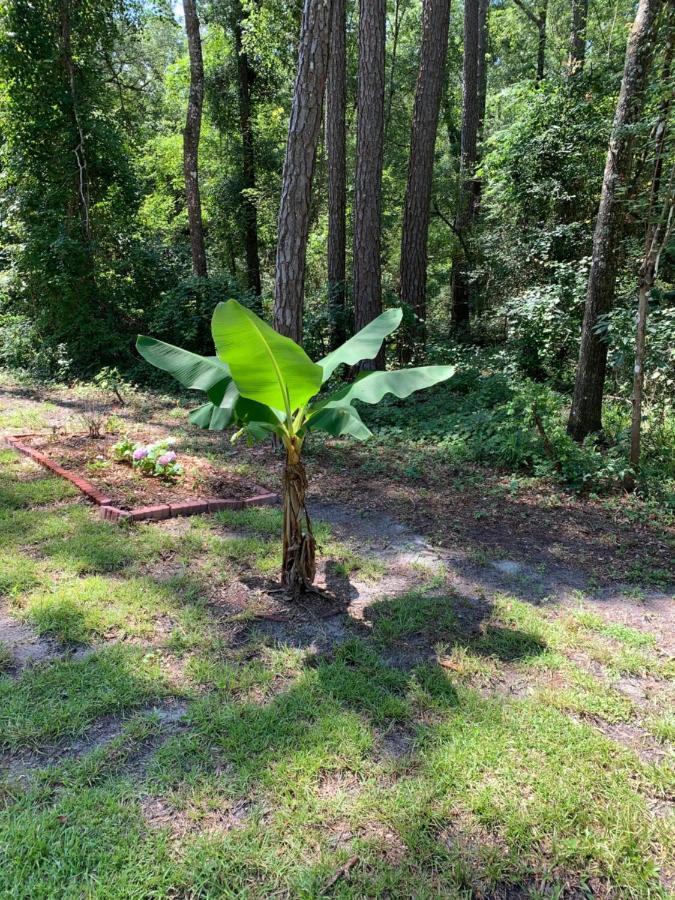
[567,0,662,441]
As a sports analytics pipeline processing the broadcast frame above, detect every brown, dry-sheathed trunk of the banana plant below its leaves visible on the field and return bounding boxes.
[281,443,316,597]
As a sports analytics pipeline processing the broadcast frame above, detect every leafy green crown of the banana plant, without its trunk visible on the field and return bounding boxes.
[136,300,455,454]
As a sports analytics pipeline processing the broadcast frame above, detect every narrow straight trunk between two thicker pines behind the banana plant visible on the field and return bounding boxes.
[326,0,347,349]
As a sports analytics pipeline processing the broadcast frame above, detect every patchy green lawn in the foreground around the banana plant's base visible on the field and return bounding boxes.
[0,396,675,900]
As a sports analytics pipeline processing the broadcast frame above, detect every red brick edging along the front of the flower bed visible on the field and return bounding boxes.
[5,434,279,522]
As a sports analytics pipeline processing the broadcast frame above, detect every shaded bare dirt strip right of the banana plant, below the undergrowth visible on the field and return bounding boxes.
[308,446,675,590]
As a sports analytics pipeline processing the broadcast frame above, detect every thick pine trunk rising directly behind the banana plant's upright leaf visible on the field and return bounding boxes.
[274,0,332,341]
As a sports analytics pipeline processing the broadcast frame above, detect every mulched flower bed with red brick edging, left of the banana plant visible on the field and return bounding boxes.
[8,432,277,519]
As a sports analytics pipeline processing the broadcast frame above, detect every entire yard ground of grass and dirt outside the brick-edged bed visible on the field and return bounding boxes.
[0,382,675,898]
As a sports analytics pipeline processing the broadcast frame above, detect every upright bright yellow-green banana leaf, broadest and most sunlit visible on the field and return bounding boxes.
[211,300,323,412]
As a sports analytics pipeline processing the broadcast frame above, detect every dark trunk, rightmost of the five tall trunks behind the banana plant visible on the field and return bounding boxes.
[451,0,487,333]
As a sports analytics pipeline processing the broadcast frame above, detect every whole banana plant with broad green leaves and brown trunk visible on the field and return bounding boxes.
[136,300,455,596]
